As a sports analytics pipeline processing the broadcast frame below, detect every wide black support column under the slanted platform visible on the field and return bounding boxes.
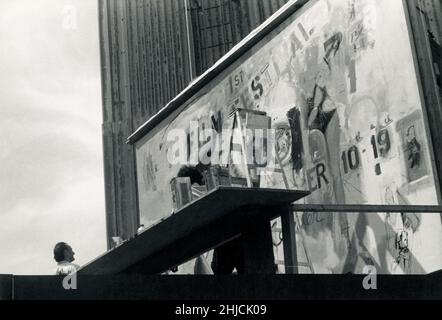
[241,211,275,274]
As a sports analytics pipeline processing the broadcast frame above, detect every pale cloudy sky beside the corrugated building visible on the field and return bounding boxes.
[0,0,106,275]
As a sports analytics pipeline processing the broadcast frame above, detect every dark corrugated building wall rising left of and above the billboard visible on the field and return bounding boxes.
[98,0,288,247]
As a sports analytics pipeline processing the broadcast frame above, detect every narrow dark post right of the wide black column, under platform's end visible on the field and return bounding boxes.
[280,206,299,274]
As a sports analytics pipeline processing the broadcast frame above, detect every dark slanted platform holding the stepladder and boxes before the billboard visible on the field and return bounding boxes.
[79,187,309,274]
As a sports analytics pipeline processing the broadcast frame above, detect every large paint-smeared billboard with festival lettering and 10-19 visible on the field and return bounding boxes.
[136,0,442,274]
